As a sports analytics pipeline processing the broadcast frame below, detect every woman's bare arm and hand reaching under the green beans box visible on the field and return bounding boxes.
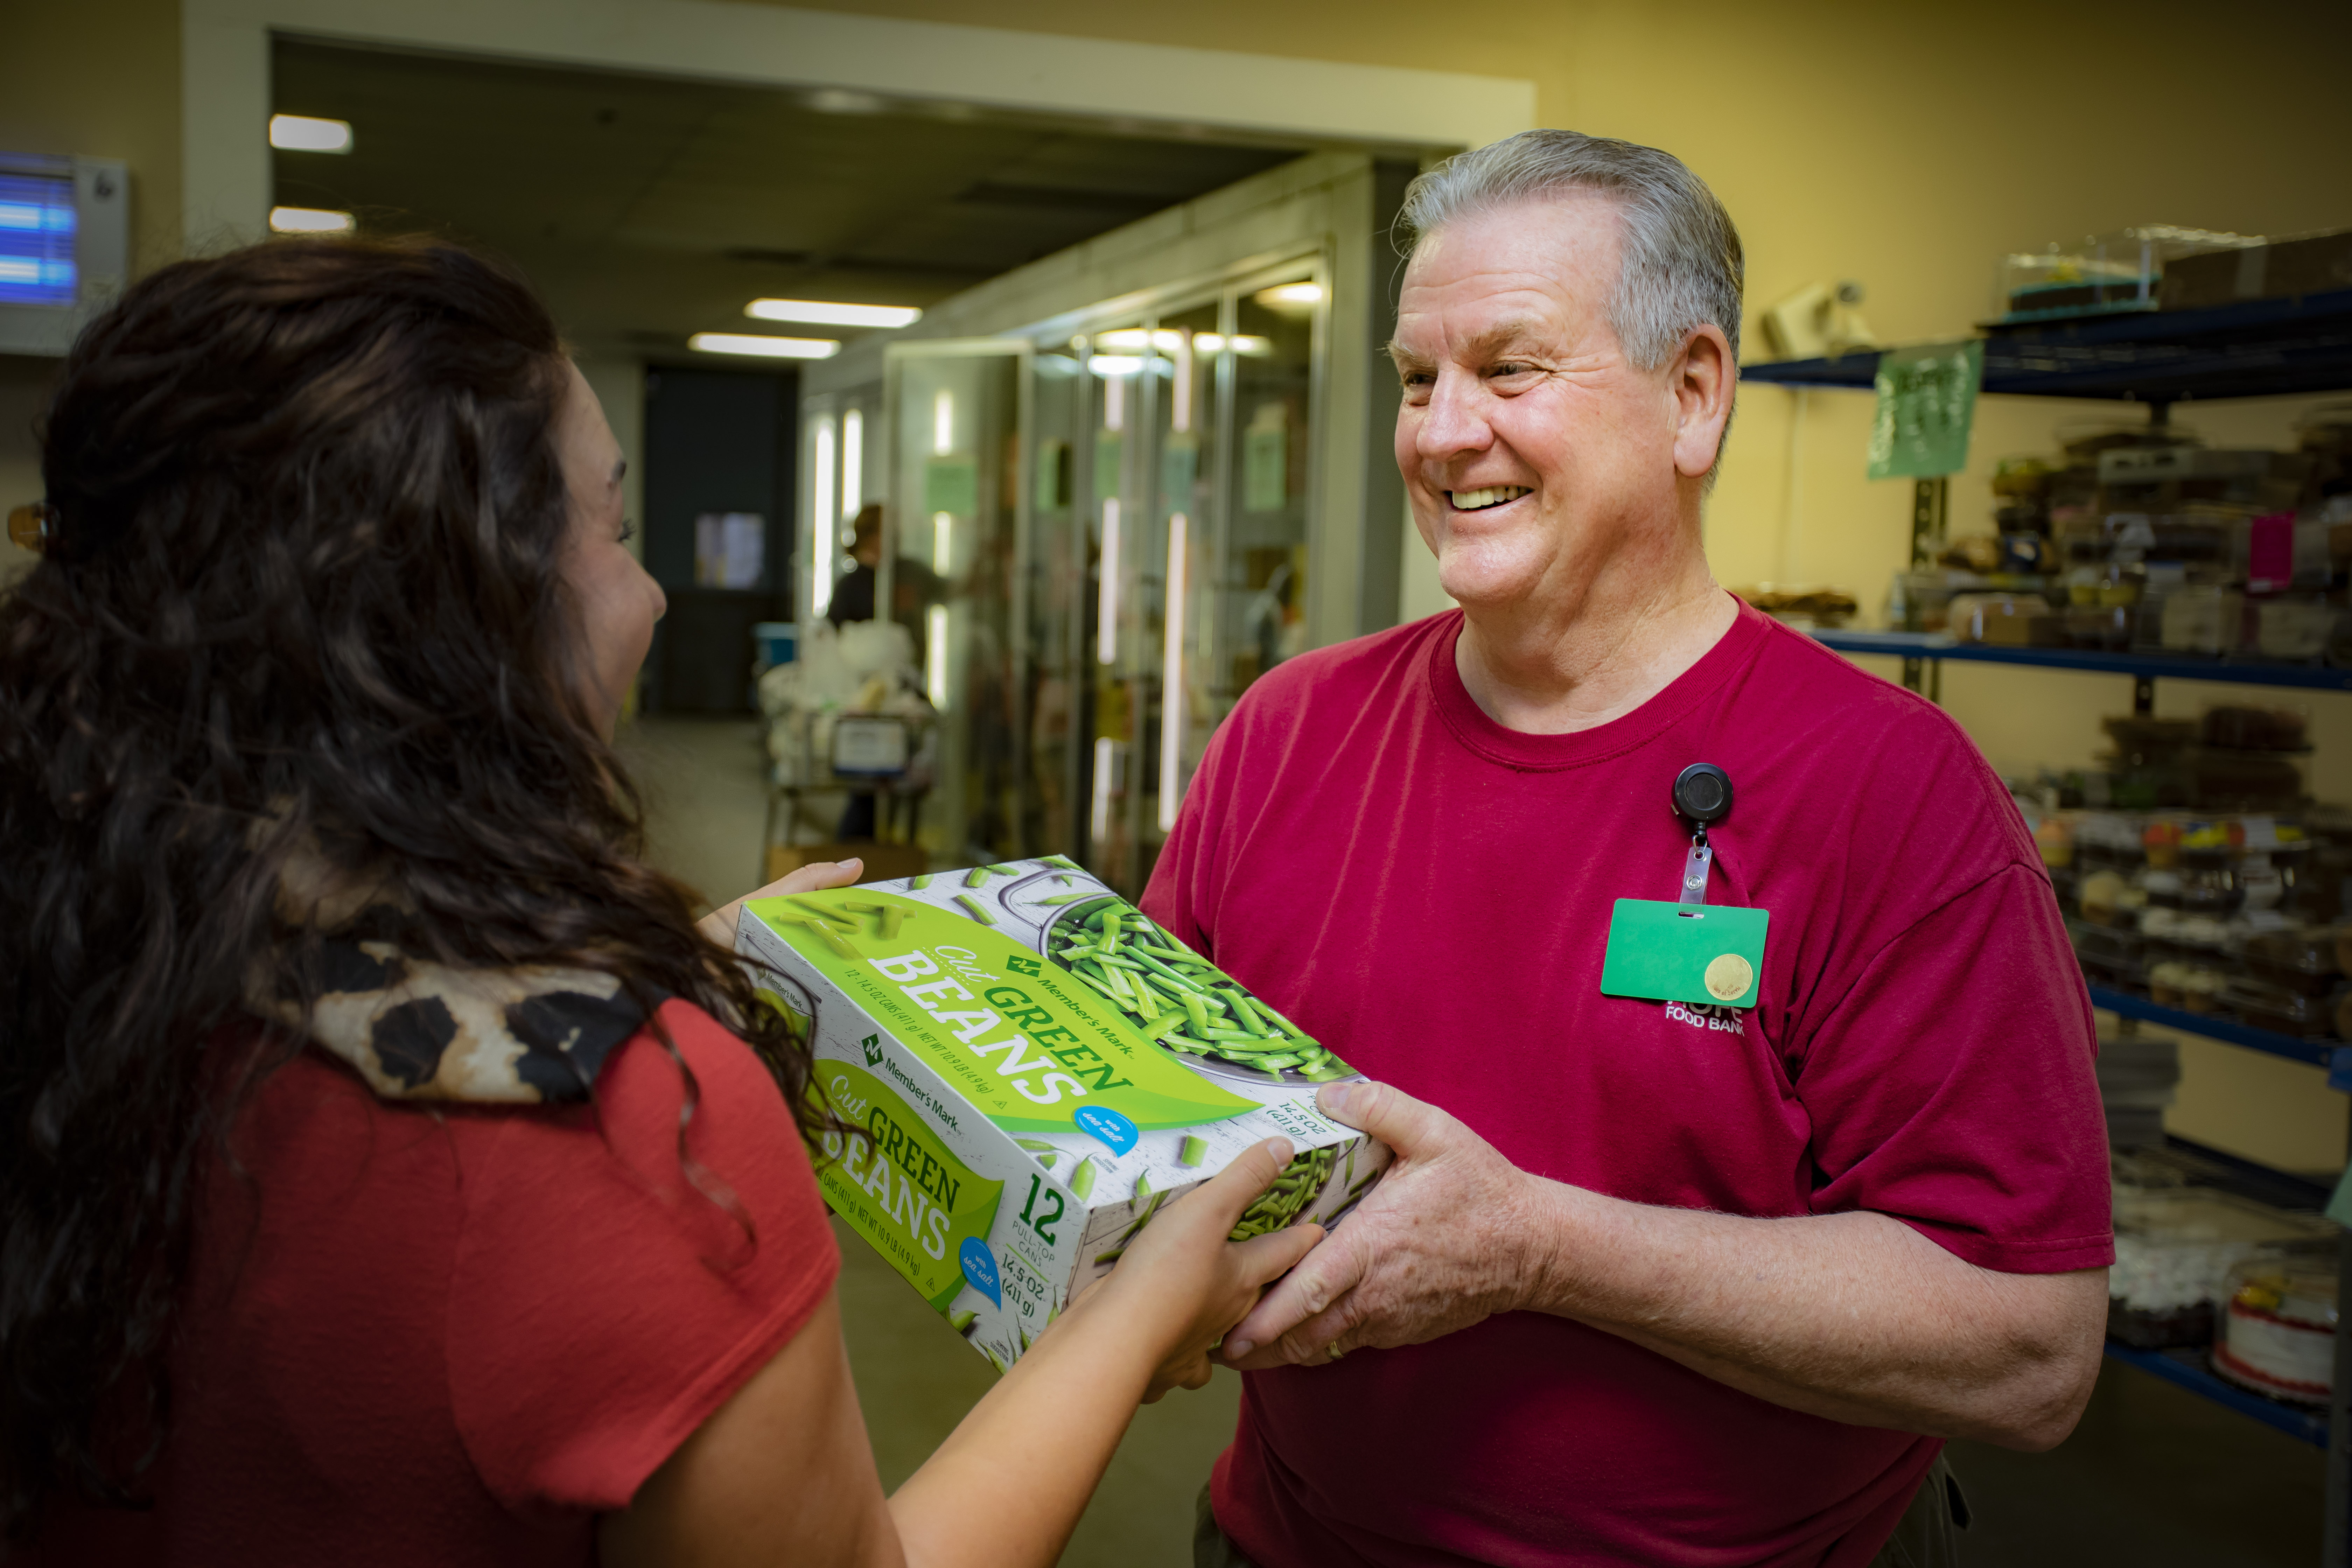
[597,1138,1322,1568]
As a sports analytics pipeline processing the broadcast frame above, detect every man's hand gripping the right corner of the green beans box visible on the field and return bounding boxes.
[1221,1084,1533,1371]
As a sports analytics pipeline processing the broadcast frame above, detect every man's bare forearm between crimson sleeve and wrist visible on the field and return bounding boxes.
[1526,1178,2107,1448]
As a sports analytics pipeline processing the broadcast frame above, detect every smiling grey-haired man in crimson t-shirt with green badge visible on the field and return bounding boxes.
[1146,132,2112,1568]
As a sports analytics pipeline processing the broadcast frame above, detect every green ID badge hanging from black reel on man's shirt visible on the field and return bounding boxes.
[1602,762,1769,1008]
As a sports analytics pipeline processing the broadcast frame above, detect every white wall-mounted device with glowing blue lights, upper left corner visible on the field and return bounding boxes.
[0,153,132,355]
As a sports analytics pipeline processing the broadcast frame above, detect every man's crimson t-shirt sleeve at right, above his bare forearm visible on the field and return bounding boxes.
[1794,865,2114,1274]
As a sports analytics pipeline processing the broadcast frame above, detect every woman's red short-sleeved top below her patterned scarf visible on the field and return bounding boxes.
[30,1001,840,1568]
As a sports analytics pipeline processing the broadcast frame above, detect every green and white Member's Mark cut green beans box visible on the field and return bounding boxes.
[736,856,1388,1368]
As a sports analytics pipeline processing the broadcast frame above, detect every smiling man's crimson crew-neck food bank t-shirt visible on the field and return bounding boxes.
[1143,609,2114,1568]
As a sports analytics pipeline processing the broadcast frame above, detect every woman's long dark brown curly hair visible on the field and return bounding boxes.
[0,240,814,1535]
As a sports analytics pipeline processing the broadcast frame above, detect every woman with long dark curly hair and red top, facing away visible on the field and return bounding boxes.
[0,240,1315,1566]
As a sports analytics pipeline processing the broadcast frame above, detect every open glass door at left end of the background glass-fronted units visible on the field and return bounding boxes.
[875,338,1030,865]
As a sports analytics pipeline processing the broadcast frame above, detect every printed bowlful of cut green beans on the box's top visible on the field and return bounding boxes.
[1040,893,1355,1084]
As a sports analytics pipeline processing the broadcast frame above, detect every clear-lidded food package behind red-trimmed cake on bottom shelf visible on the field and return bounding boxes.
[2107,1182,2331,1349]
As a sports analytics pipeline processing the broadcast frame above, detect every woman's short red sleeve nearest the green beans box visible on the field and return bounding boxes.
[447,1001,840,1514]
